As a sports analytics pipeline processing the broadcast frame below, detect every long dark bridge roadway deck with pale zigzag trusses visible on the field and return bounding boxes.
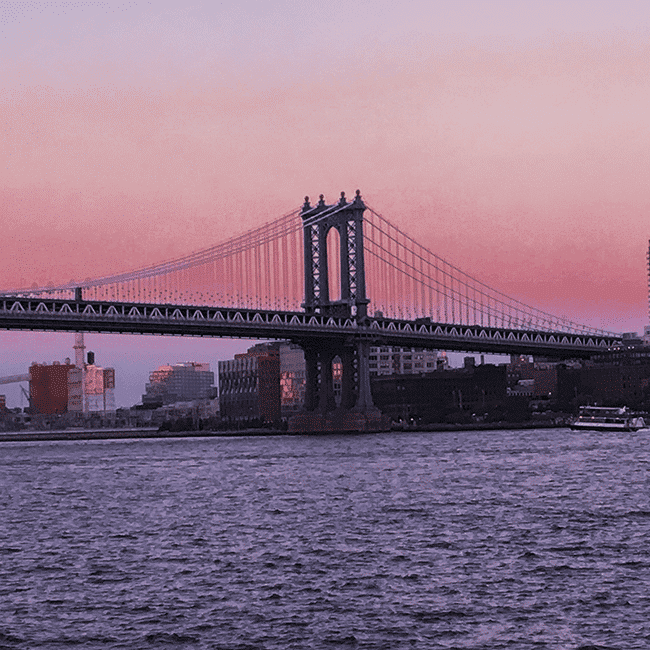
[0,296,621,359]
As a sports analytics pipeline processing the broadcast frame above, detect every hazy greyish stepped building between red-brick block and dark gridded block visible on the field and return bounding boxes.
[142,361,215,406]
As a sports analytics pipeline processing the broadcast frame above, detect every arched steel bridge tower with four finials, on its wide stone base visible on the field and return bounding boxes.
[289,190,389,431]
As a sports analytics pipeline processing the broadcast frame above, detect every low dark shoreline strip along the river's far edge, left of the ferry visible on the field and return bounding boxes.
[0,422,568,443]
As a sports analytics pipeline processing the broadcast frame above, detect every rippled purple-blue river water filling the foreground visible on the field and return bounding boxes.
[0,430,650,650]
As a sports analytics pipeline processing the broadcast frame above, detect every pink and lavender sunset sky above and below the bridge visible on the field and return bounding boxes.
[0,0,650,406]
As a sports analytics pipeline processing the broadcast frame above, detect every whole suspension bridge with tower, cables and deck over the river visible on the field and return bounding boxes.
[0,190,620,428]
